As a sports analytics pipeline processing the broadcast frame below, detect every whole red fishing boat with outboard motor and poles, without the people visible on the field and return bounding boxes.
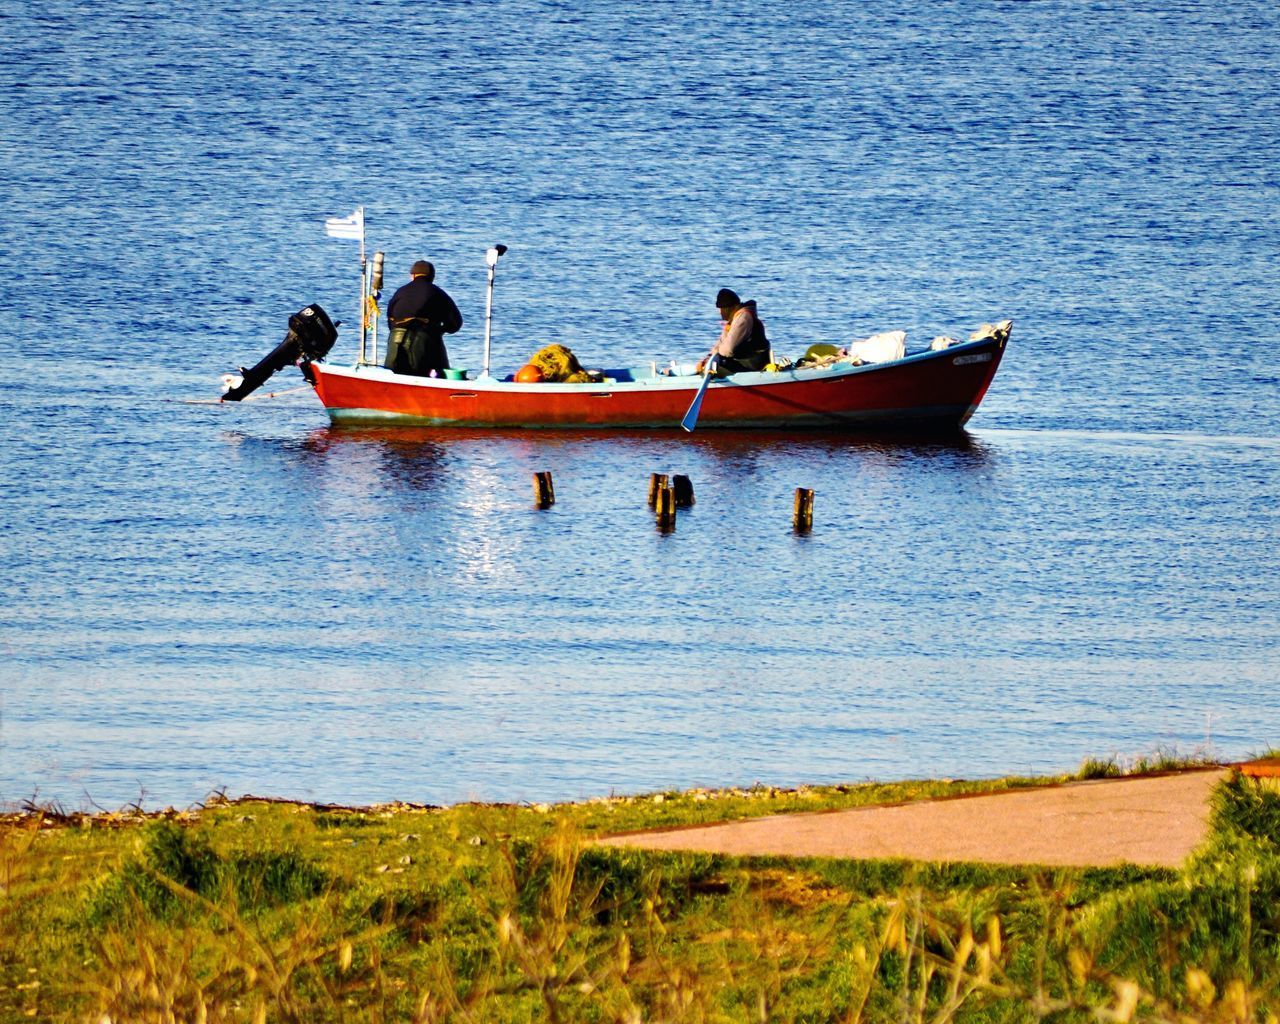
[223,234,1011,430]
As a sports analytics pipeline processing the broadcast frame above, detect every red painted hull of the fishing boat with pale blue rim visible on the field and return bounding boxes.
[307,335,1007,430]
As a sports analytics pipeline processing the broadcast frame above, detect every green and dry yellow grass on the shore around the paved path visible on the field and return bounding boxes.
[0,769,1280,1024]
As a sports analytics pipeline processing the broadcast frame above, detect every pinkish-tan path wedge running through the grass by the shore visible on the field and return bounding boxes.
[600,768,1226,868]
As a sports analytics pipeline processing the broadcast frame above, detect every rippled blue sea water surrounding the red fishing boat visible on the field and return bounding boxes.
[0,0,1280,809]
